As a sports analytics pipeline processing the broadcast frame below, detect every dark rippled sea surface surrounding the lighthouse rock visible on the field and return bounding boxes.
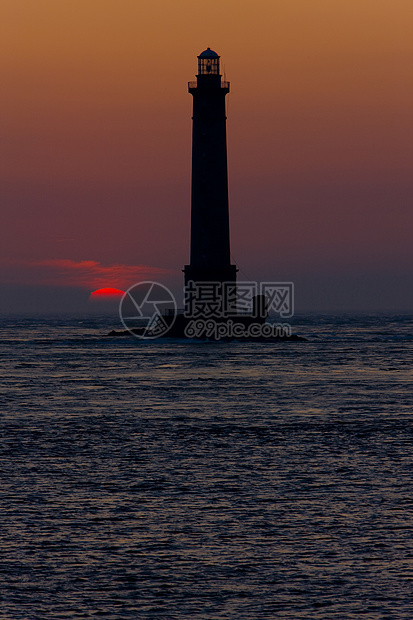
[0,313,413,620]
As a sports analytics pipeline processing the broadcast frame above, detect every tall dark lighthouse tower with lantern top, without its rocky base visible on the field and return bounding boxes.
[184,47,237,286]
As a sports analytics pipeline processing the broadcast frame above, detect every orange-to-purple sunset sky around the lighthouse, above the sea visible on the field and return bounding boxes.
[0,0,413,313]
